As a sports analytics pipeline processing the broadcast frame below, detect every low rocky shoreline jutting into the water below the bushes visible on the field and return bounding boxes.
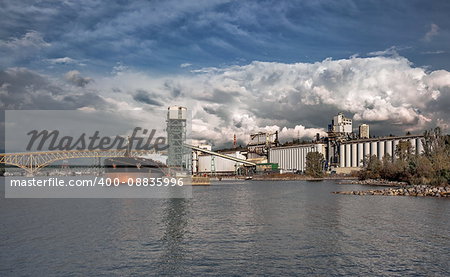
[333,185,450,197]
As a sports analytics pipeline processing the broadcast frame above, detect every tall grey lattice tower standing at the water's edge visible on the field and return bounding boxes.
[167,106,187,168]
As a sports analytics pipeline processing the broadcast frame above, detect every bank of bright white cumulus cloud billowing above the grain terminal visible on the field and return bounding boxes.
[27,55,450,145]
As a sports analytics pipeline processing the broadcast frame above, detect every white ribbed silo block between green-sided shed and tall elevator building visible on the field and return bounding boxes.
[269,143,326,172]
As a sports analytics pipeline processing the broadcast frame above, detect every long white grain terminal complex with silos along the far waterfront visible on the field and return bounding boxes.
[189,110,423,174]
